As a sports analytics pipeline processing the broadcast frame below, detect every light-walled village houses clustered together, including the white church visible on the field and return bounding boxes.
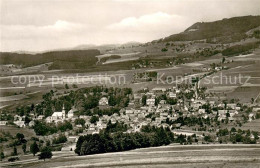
[0,87,255,140]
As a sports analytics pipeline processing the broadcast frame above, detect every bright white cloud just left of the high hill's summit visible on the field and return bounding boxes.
[106,12,191,42]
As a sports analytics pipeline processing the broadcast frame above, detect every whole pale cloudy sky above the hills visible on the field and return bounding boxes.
[0,0,260,51]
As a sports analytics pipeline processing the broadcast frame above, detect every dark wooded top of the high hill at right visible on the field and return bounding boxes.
[161,16,260,43]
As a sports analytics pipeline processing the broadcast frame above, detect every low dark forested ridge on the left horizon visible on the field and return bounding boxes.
[0,50,100,69]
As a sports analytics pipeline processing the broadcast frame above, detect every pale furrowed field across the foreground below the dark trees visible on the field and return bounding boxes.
[2,144,260,168]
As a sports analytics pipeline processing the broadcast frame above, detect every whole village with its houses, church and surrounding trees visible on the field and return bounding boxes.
[0,80,260,162]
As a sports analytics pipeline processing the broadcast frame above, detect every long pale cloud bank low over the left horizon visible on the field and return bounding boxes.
[0,20,90,51]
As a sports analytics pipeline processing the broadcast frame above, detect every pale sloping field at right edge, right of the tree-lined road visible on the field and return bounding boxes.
[197,49,260,103]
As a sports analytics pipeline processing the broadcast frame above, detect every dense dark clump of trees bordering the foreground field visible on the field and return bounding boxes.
[75,126,174,155]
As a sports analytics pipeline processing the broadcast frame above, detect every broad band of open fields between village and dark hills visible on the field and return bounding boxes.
[0,49,260,107]
